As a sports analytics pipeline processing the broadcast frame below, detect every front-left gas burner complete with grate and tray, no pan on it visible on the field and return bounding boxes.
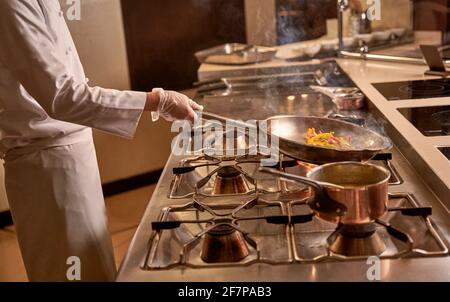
[145,194,314,269]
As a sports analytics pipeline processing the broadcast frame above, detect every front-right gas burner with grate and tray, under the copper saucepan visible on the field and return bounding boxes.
[291,193,447,263]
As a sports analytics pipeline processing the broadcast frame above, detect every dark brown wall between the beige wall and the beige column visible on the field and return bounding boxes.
[121,0,246,90]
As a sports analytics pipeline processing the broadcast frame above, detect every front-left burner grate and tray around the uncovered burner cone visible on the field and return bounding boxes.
[143,196,296,270]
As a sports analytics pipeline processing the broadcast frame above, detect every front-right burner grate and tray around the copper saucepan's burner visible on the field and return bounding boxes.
[292,193,448,262]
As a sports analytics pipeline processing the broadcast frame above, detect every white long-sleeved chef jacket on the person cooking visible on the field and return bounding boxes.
[0,0,146,158]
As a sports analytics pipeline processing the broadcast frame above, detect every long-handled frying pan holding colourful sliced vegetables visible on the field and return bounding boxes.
[202,112,392,164]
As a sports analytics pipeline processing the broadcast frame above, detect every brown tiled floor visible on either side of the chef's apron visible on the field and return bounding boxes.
[0,186,154,282]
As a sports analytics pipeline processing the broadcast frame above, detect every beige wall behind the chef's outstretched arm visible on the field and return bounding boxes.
[60,0,172,183]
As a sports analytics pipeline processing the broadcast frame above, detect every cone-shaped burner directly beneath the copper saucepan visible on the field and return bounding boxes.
[327,223,386,257]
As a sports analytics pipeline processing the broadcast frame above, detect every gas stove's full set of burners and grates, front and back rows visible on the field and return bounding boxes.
[142,126,448,270]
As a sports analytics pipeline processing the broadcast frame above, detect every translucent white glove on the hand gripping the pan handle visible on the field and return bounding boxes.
[152,88,203,122]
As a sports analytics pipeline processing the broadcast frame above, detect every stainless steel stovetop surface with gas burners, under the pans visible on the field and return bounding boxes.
[118,62,450,281]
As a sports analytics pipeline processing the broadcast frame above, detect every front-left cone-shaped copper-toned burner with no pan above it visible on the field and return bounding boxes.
[201,221,250,263]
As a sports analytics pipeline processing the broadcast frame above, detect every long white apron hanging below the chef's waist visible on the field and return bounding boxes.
[5,129,116,281]
